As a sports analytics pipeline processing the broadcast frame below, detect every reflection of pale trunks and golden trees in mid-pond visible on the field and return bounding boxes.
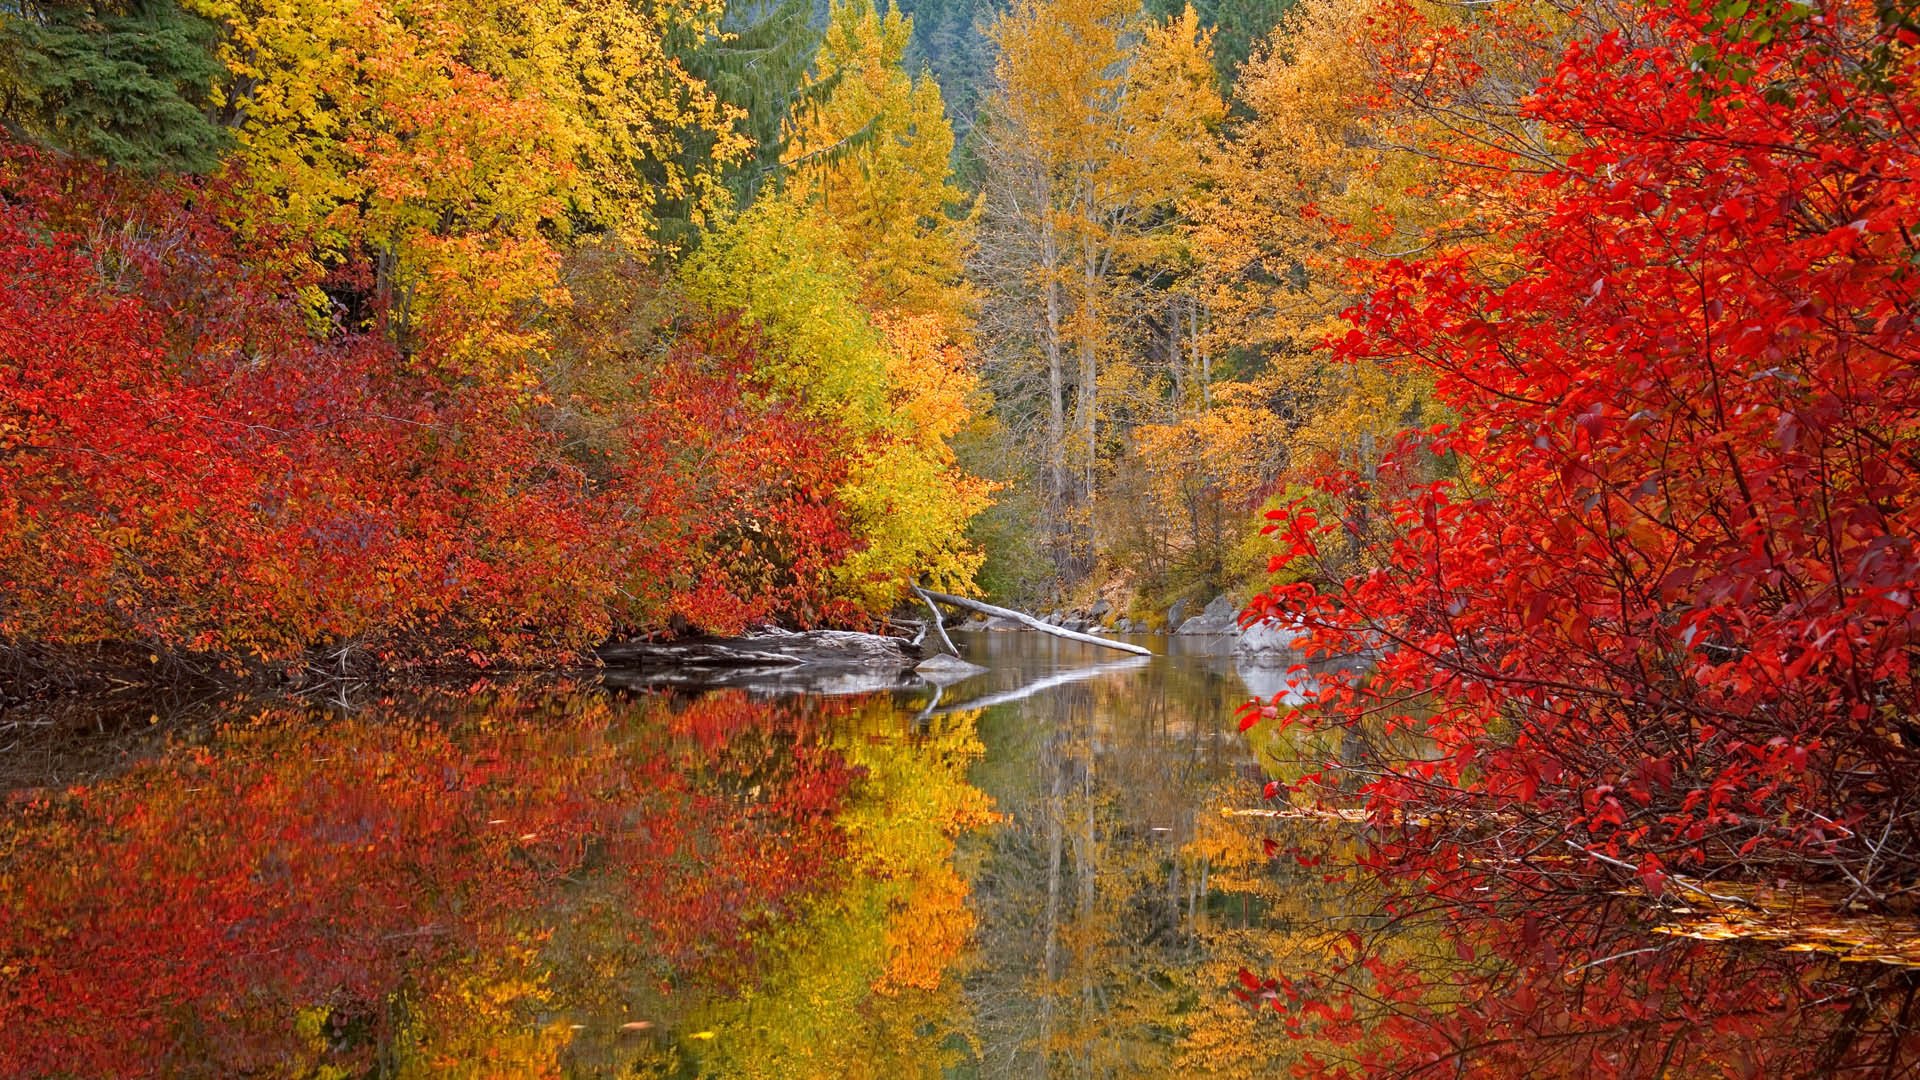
[968,671,1242,1076]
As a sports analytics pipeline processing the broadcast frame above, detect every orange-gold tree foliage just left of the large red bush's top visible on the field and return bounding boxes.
[1188,0,1565,541]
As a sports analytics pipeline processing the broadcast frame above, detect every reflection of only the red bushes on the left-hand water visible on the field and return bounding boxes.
[0,694,852,1076]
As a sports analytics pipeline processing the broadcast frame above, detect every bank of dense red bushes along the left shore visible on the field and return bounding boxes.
[0,148,871,663]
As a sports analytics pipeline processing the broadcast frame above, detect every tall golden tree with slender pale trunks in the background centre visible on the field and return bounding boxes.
[981,0,1225,573]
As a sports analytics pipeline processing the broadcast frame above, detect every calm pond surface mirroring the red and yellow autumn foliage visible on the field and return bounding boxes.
[0,634,1916,1078]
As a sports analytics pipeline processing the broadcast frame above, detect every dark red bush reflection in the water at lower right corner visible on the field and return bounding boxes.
[1235,890,1920,1080]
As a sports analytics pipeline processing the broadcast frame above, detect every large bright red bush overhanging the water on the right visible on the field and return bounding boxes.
[1256,0,1920,897]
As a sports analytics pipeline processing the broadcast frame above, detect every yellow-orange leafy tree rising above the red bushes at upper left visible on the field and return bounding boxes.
[188,0,741,379]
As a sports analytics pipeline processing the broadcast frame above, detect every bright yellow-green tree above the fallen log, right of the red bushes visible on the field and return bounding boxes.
[687,0,987,607]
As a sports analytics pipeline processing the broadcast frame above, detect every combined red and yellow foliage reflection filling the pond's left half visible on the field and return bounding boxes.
[0,684,991,1076]
